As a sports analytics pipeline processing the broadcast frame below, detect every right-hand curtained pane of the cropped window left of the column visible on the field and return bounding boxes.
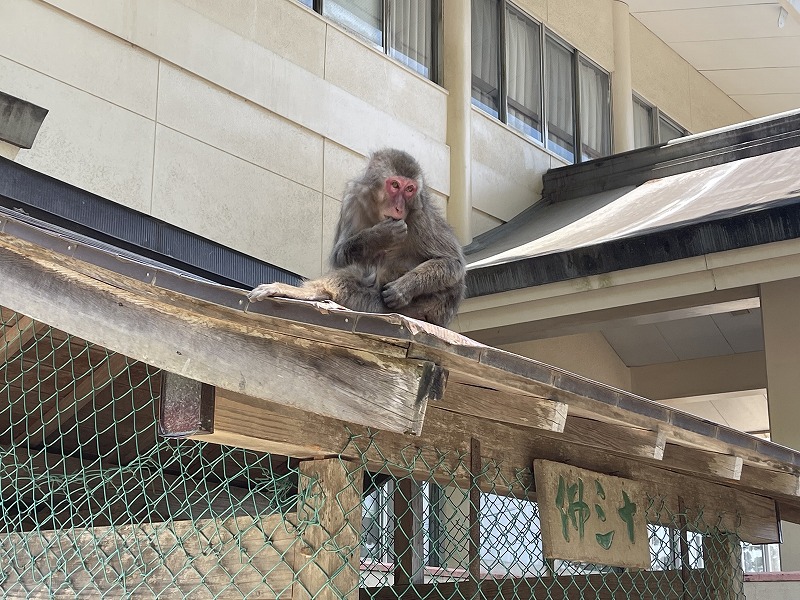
[389,0,438,79]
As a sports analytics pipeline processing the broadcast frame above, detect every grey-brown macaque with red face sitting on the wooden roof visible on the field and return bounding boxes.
[249,149,465,326]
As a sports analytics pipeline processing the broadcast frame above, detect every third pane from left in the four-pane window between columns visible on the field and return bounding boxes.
[545,38,575,162]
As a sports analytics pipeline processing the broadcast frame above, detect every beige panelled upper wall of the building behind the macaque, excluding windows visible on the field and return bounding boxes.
[0,0,748,266]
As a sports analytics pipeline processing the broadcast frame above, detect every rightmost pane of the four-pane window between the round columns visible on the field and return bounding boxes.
[578,60,611,160]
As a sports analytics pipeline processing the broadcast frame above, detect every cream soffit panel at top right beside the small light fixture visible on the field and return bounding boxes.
[633,2,800,43]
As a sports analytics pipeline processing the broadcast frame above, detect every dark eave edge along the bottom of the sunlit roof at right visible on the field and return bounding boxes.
[467,196,800,297]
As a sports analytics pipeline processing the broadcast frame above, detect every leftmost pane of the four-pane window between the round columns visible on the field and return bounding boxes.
[472,0,500,117]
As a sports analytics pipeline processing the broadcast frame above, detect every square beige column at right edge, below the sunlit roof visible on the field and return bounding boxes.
[761,279,800,571]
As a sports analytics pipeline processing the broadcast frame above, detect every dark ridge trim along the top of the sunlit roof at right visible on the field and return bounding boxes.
[542,111,800,203]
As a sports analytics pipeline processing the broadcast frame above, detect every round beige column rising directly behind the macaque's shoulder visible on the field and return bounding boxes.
[442,2,472,245]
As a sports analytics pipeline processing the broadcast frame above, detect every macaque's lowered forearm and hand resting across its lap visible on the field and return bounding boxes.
[381,257,466,310]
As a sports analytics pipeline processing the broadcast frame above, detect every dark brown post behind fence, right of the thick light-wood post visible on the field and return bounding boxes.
[394,477,425,586]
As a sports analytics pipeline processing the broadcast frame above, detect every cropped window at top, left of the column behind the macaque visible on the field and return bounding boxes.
[300,0,441,81]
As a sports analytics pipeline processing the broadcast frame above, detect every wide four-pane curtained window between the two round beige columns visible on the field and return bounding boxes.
[472,0,611,162]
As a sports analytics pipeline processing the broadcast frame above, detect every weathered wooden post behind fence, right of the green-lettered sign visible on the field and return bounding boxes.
[703,532,744,600]
